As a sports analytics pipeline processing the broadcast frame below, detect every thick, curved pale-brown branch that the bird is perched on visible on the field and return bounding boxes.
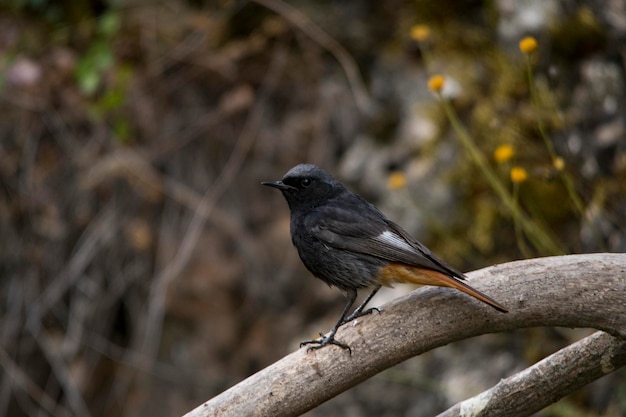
[185,254,626,417]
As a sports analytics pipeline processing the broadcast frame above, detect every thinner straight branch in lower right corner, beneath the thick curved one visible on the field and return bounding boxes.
[438,332,626,417]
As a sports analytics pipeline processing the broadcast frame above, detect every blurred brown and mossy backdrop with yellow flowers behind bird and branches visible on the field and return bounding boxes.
[0,0,626,417]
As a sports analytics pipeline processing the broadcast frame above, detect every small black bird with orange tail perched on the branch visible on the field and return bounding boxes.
[262,164,507,351]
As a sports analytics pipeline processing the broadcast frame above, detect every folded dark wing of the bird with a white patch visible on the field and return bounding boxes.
[305,200,464,279]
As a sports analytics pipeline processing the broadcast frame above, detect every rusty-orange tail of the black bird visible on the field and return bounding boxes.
[378,262,508,313]
